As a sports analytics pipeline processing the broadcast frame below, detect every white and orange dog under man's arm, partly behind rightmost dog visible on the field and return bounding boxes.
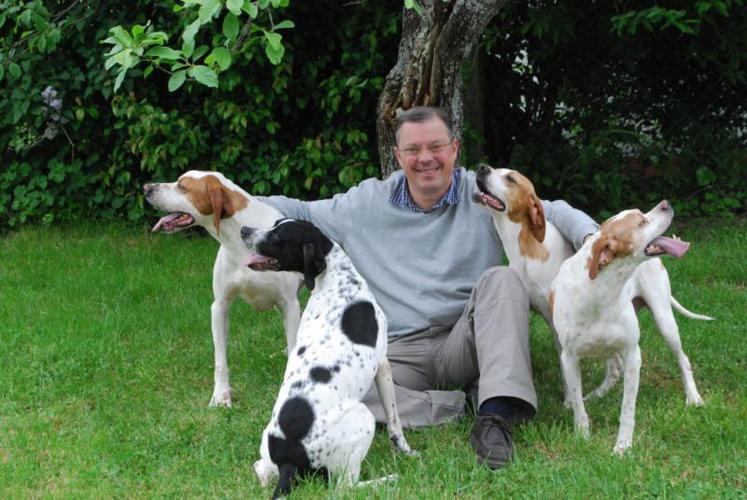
[474,165,712,406]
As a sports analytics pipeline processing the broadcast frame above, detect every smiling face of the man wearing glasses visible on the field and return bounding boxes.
[394,116,459,208]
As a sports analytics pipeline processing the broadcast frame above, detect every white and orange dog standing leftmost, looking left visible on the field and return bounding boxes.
[143,170,302,406]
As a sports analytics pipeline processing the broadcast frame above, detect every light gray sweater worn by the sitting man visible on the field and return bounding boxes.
[260,169,598,336]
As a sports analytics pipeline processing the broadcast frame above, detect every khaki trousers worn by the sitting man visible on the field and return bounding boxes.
[363,266,537,428]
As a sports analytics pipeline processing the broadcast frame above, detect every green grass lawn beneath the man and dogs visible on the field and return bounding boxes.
[0,220,747,498]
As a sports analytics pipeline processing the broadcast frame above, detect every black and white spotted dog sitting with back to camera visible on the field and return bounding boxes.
[241,219,414,497]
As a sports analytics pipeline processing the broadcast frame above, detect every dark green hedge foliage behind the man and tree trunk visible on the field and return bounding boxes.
[0,0,747,230]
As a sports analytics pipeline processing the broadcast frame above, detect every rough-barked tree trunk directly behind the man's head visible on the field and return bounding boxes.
[376,0,507,177]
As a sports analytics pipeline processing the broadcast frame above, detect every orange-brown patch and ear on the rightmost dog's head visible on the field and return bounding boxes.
[586,211,645,279]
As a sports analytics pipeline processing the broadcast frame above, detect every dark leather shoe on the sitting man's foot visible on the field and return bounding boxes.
[469,415,514,470]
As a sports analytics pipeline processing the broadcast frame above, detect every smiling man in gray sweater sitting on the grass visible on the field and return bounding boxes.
[264,107,597,469]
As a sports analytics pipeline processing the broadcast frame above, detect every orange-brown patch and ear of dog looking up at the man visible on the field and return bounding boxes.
[504,170,550,262]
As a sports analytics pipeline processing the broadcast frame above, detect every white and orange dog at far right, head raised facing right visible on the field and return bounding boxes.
[550,201,689,454]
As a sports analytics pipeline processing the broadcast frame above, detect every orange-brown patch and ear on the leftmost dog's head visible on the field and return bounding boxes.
[178,175,249,235]
